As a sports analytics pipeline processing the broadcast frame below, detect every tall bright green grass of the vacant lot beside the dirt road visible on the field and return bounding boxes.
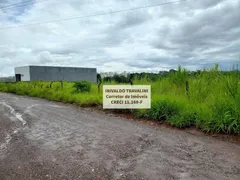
[0,66,240,134]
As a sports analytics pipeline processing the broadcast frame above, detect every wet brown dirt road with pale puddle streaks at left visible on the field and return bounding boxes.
[0,93,240,180]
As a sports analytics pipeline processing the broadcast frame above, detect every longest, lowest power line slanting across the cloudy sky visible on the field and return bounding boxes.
[0,0,187,30]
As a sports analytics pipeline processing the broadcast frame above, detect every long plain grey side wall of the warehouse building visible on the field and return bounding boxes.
[30,66,97,83]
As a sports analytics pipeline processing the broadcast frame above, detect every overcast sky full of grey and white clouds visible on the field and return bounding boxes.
[0,0,240,76]
